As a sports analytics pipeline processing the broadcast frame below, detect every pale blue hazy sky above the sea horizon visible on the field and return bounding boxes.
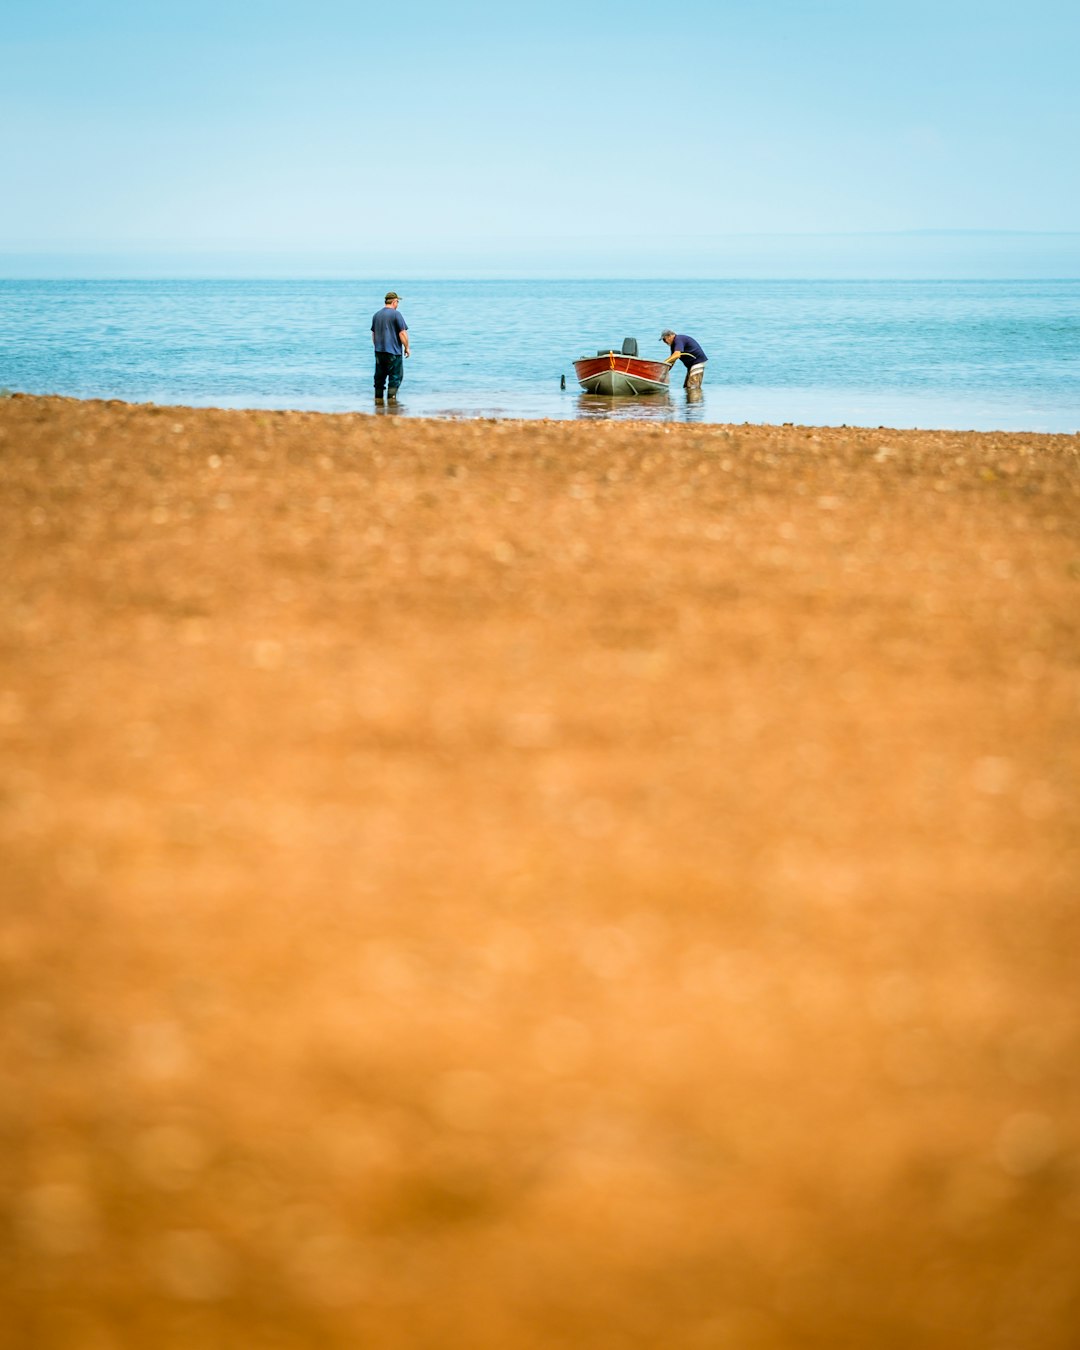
[0,0,1080,277]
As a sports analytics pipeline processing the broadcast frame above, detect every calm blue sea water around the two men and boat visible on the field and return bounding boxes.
[0,278,1080,432]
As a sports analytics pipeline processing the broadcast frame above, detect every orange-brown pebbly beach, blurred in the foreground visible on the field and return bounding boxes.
[0,397,1080,1350]
